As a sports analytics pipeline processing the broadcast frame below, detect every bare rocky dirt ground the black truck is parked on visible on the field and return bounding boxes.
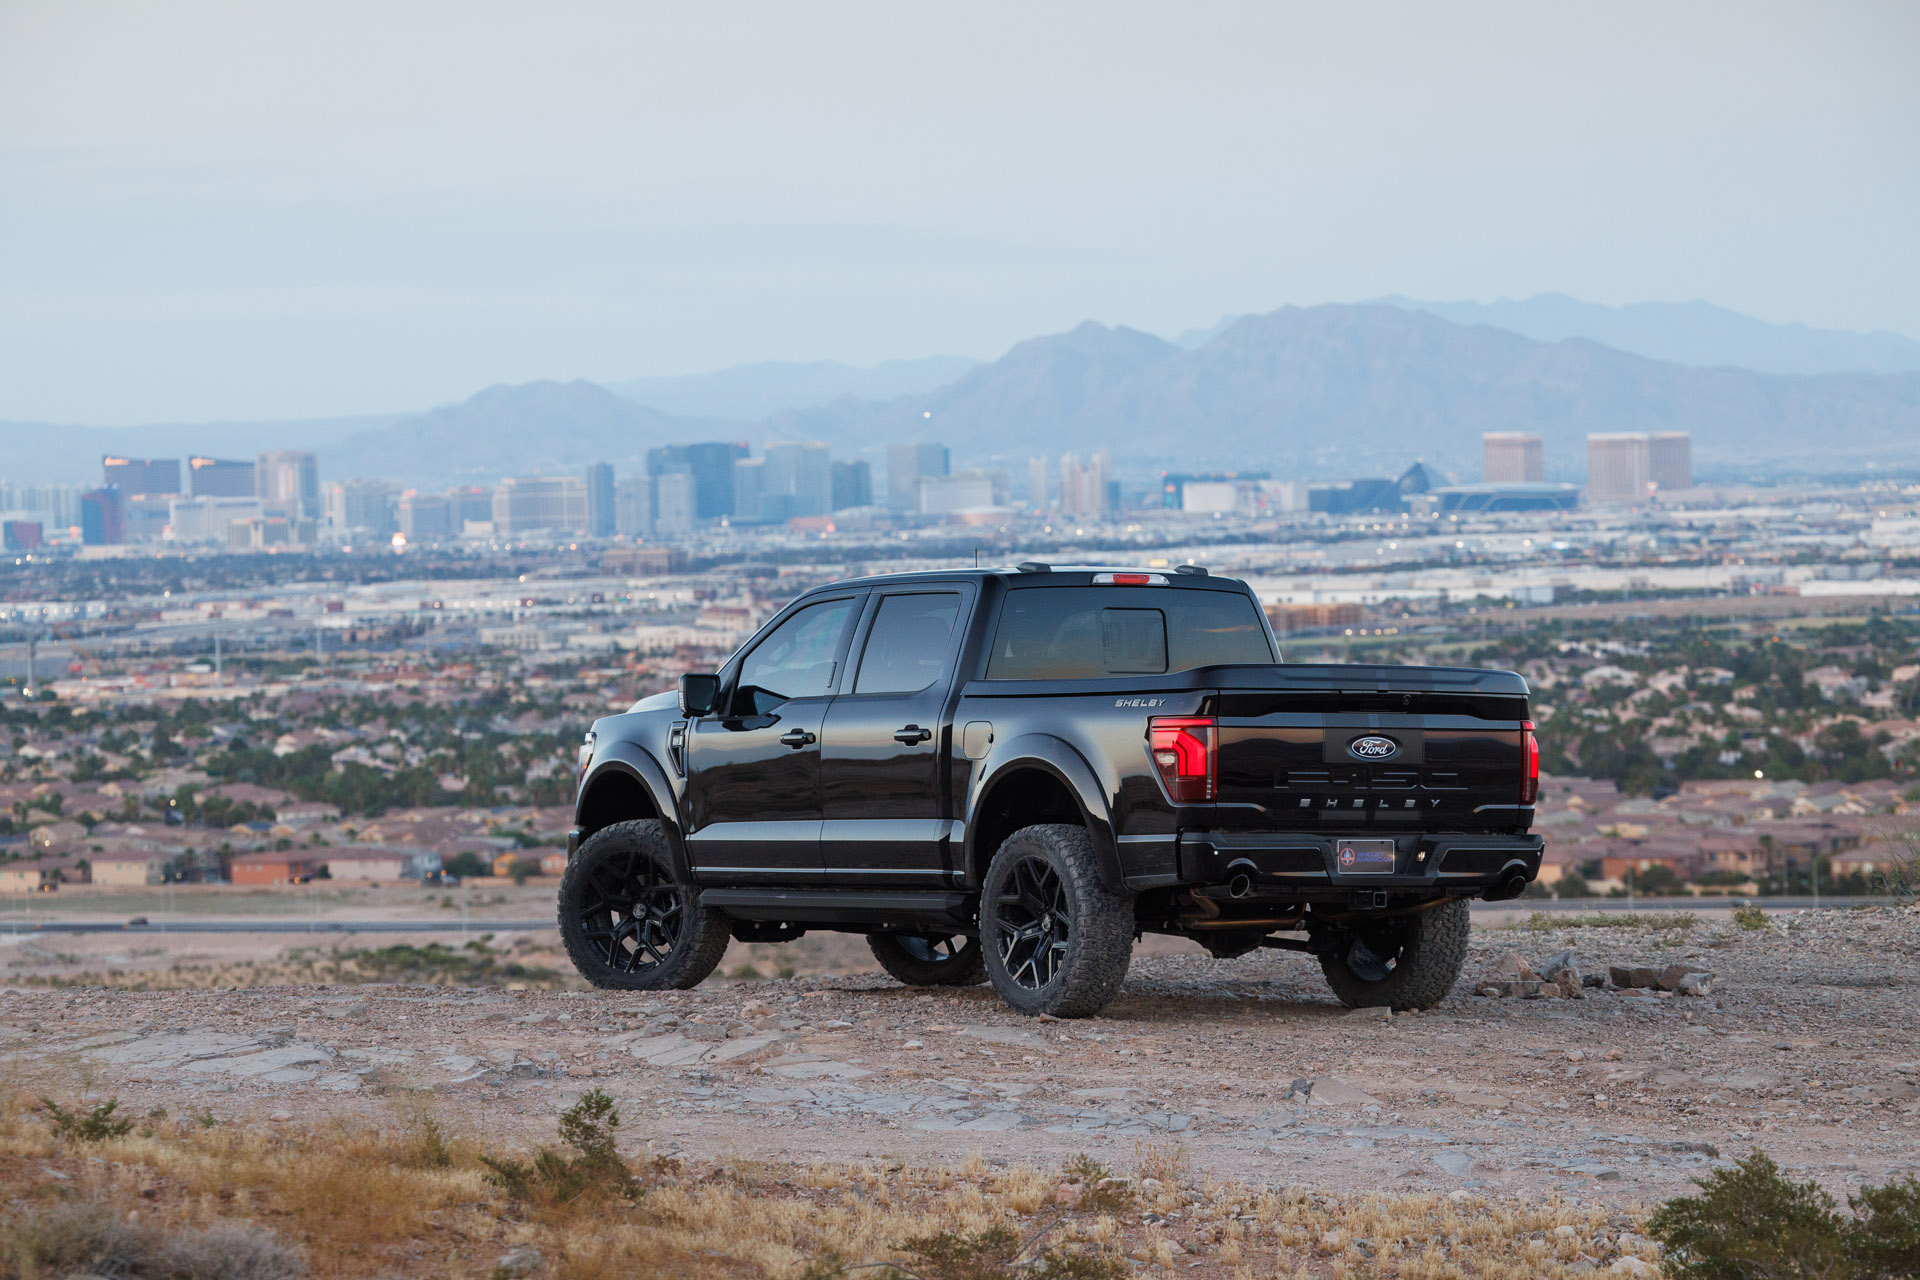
[0,908,1920,1205]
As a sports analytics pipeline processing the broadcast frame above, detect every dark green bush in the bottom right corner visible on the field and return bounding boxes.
[1647,1151,1920,1280]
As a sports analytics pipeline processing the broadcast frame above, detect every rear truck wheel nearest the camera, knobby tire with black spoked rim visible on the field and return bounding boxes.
[979,823,1133,1017]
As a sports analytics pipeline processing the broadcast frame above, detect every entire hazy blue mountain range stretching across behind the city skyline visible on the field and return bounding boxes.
[0,296,1920,486]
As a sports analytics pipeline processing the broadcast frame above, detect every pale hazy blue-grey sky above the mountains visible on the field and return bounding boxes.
[0,0,1920,424]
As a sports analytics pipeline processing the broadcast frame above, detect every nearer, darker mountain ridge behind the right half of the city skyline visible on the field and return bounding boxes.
[768,305,1920,478]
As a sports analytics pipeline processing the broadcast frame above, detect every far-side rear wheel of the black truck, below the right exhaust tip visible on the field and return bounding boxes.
[1321,898,1471,1011]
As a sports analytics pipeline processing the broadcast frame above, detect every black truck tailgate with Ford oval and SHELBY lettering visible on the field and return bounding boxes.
[1210,666,1532,835]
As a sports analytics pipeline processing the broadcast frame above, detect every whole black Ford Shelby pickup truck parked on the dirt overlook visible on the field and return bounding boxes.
[559,564,1542,1017]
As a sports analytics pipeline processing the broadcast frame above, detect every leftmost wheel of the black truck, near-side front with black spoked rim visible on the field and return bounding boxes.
[557,819,730,990]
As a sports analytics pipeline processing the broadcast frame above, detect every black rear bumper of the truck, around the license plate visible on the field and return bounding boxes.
[1179,831,1546,900]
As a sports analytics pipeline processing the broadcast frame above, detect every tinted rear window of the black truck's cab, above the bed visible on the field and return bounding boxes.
[987,587,1275,679]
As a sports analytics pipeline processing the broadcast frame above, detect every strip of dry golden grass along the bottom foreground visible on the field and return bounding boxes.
[0,1090,1697,1280]
